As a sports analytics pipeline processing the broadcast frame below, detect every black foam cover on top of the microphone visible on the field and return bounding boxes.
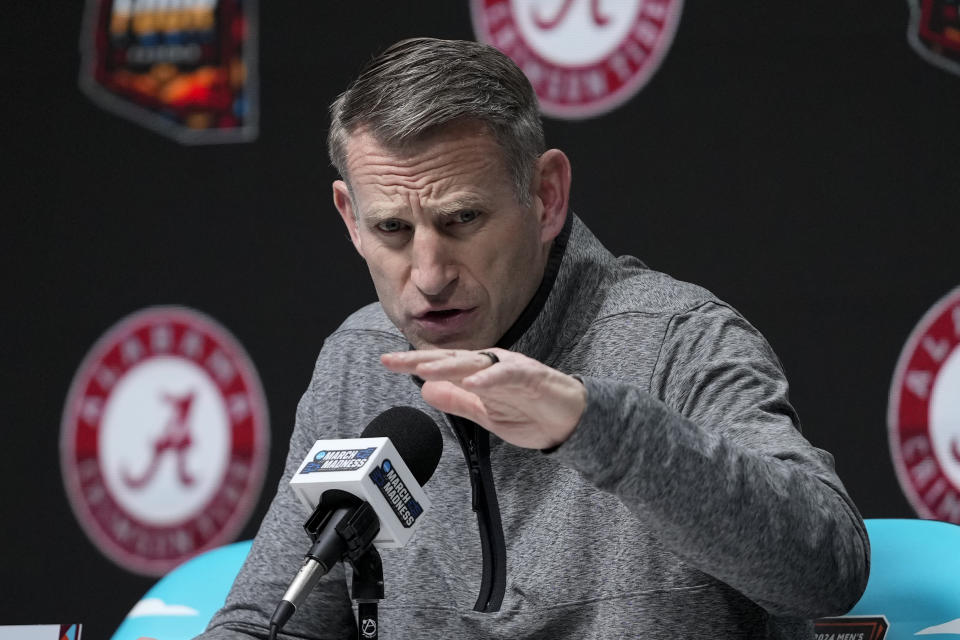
[360,407,443,487]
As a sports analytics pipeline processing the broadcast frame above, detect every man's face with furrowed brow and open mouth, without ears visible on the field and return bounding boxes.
[334,123,550,349]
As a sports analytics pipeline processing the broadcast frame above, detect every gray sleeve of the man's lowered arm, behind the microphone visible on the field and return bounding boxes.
[198,341,357,640]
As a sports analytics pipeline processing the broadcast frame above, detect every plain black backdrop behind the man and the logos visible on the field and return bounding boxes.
[0,0,960,638]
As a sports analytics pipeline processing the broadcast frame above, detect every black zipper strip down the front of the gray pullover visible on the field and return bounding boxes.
[449,416,507,613]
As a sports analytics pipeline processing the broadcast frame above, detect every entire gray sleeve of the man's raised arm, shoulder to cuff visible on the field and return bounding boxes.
[555,303,869,619]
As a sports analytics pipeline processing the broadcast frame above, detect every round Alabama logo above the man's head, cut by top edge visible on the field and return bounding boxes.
[470,0,683,119]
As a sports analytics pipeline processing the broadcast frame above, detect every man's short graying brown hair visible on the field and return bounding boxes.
[327,38,546,204]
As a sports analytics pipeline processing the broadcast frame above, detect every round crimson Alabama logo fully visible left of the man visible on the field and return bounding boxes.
[60,307,270,575]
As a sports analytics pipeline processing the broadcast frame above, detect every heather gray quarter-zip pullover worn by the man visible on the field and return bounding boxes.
[202,219,869,640]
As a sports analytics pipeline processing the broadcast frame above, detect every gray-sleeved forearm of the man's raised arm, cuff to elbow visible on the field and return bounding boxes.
[556,378,869,618]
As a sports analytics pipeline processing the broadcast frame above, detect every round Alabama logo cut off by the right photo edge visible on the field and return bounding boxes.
[888,287,960,524]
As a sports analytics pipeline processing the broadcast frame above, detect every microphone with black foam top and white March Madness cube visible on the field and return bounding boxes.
[270,407,443,637]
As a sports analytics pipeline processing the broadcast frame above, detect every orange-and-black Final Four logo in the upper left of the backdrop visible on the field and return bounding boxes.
[80,0,259,144]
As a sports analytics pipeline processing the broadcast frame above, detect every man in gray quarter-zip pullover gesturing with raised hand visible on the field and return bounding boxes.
[203,39,869,639]
